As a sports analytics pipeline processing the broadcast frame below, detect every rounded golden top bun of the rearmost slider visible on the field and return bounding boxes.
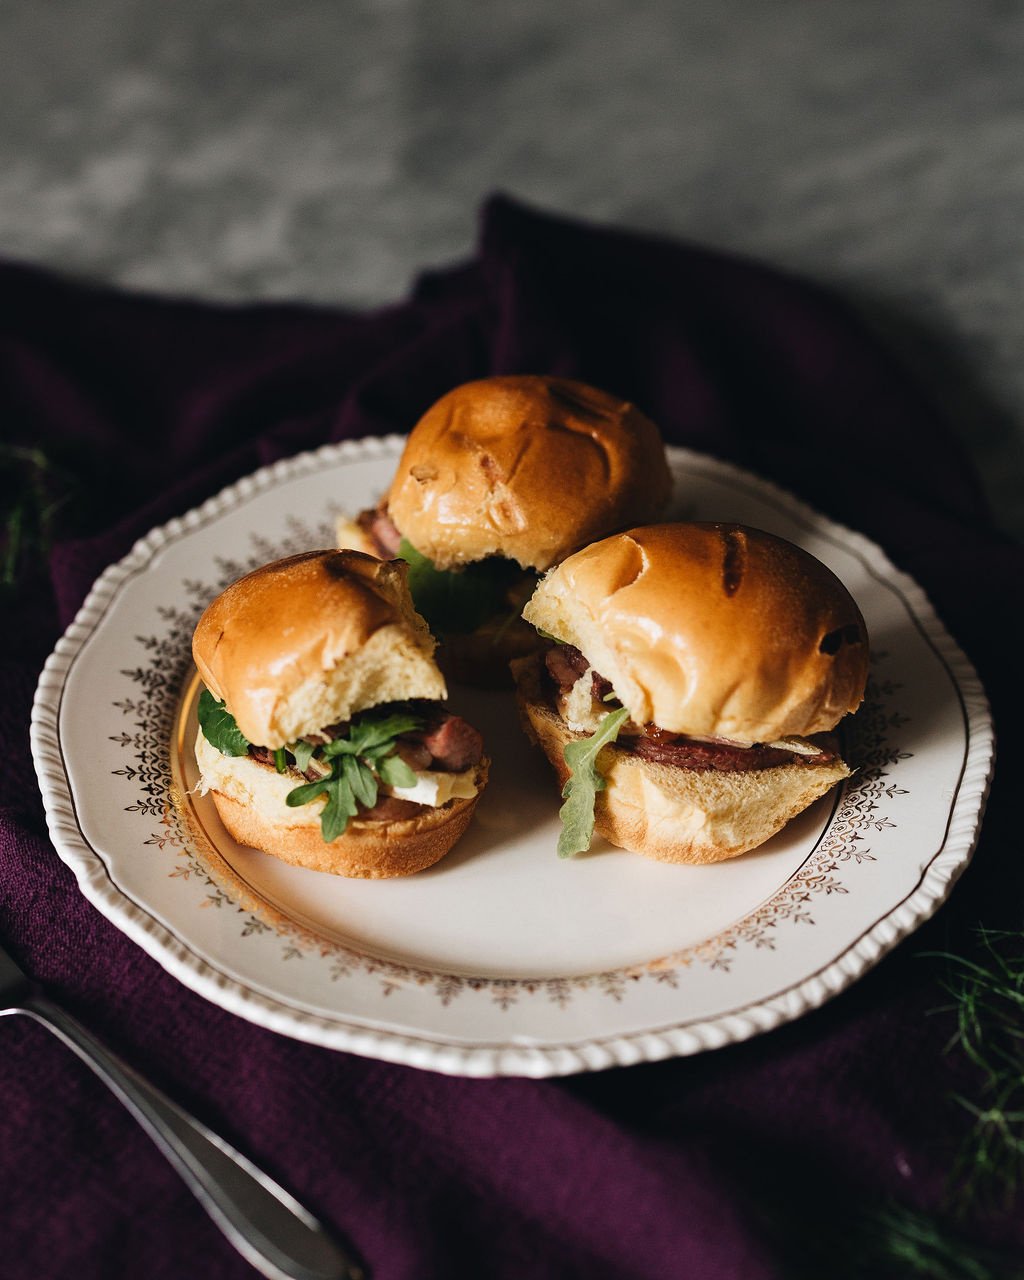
[388,376,672,570]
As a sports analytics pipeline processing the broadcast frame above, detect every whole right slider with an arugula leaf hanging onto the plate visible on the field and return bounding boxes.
[512,524,868,863]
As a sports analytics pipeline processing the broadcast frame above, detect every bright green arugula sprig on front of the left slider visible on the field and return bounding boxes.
[285,713,422,844]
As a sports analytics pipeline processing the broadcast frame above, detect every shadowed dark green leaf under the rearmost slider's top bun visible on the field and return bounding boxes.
[398,538,524,636]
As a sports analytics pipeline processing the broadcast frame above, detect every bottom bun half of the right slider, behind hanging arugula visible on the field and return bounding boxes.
[513,659,850,864]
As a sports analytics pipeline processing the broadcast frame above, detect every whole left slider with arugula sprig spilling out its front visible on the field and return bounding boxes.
[192,550,488,878]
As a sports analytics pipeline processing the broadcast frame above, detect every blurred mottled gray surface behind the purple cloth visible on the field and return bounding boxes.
[0,0,1024,535]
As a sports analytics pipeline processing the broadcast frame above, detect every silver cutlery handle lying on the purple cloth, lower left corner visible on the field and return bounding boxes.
[17,993,369,1280]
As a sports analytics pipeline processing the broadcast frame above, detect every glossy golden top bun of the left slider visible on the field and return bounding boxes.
[192,550,447,748]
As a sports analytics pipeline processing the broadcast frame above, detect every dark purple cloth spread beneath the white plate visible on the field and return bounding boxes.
[0,192,1024,1280]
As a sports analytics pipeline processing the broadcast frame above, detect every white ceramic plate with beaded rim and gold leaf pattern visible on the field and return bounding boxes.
[32,438,992,1076]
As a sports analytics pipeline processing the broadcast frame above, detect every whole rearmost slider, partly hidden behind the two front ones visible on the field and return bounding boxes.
[338,376,672,685]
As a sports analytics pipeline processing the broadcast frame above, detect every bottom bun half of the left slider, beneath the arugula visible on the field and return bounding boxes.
[196,735,490,879]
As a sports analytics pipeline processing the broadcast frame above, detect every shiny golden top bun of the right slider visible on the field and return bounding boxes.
[524,524,868,744]
